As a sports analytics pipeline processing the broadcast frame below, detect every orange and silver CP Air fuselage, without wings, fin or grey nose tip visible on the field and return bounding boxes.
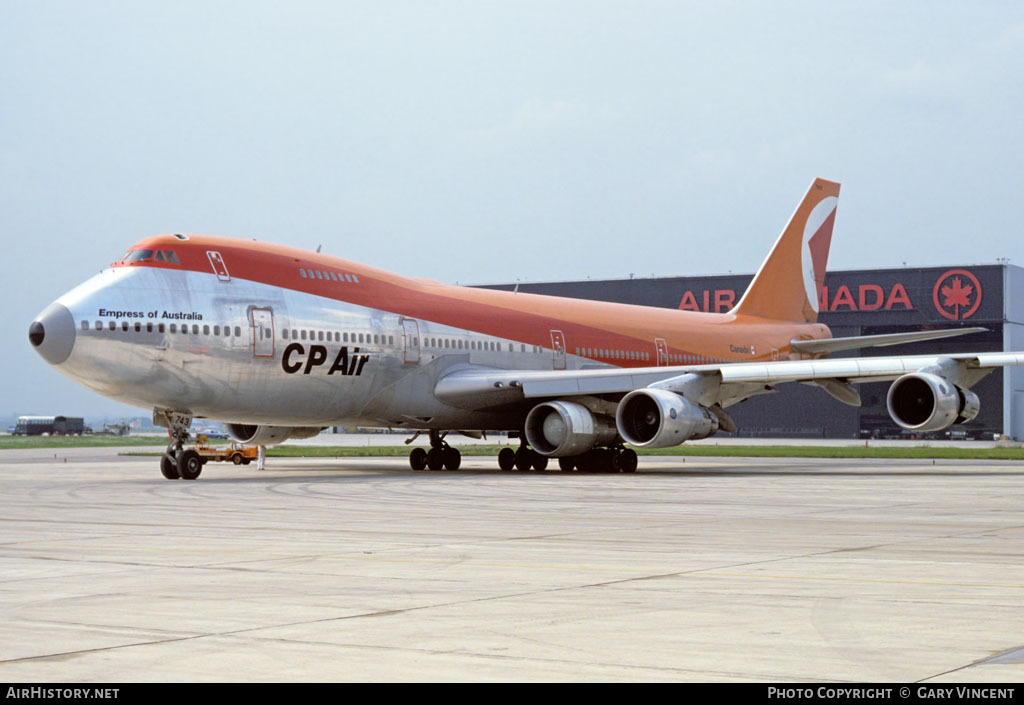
[40,236,828,430]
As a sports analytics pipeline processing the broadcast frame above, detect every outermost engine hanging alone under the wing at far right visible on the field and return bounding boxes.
[886,372,981,431]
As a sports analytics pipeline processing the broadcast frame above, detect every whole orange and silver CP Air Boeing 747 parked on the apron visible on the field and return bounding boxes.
[29,179,1024,480]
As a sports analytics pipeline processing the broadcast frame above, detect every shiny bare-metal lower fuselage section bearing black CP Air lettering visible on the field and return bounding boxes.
[51,267,589,429]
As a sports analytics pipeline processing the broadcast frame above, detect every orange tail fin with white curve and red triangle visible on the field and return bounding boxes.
[731,178,840,323]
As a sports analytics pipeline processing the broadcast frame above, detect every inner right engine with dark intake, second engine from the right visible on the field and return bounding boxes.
[615,388,719,448]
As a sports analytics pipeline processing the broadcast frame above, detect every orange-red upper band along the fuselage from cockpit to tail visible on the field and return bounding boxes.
[112,235,830,367]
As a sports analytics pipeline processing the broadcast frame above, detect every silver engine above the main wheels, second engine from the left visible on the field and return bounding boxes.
[526,402,616,458]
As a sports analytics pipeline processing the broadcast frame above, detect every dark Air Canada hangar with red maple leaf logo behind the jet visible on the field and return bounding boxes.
[487,264,1024,441]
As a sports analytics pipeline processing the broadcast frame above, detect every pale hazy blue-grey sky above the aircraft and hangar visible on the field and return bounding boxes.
[0,0,1024,415]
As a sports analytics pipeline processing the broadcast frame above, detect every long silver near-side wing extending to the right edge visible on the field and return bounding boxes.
[434,353,1024,408]
